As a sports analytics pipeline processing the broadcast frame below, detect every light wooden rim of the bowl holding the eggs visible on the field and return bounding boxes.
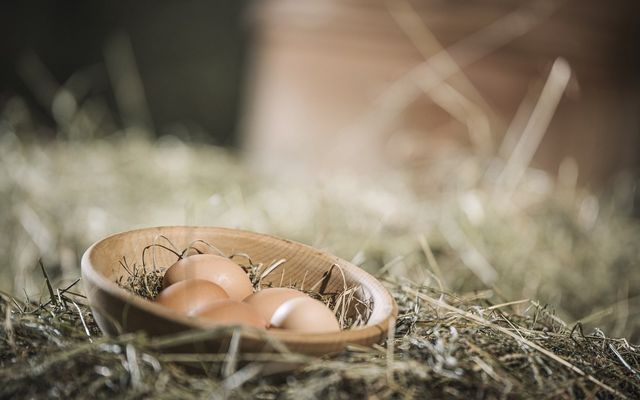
[81,225,398,344]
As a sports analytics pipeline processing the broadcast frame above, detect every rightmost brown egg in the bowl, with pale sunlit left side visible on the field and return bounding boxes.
[271,296,340,333]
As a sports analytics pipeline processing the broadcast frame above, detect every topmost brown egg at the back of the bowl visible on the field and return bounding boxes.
[162,254,253,301]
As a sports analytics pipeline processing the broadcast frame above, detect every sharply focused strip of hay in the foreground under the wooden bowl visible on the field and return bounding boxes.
[0,270,640,399]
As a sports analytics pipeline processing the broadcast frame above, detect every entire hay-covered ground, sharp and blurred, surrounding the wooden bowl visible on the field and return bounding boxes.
[0,100,640,399]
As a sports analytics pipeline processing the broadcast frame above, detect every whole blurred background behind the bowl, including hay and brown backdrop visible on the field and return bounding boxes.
[0,0,640,341]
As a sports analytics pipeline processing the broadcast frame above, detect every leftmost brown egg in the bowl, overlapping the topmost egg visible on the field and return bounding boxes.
[155,279,229,314]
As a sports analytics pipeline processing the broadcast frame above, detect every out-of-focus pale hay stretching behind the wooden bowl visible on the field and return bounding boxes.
[0,109,640,341]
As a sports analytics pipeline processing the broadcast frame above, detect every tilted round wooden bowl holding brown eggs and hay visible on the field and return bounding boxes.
[82,226,398,355]
